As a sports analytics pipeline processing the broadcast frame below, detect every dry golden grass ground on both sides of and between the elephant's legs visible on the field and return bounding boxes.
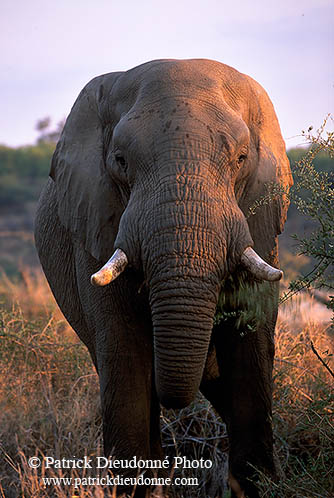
[0,271,334,498]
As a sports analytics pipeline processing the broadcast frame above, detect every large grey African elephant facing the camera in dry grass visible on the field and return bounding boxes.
[36,59,291,497]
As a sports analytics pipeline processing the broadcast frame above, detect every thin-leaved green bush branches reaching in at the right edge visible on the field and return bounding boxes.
[249,115,334,325]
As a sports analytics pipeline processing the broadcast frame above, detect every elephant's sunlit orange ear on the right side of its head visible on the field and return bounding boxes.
[239,78,292,261]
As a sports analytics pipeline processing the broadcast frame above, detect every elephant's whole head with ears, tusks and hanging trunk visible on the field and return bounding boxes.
[50,60,291,407]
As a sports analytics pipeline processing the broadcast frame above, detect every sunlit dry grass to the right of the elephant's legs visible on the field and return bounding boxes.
[262,322,334,498]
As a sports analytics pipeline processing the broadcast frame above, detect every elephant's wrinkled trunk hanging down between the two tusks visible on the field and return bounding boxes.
[141,189,232,408]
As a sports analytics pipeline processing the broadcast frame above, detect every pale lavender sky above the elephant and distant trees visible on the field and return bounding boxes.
[0,0,334,148]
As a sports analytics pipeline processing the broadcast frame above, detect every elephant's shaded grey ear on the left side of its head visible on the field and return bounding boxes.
[50,73,124,261]
